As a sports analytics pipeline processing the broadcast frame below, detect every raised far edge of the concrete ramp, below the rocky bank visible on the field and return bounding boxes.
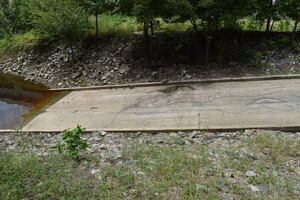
[49,74,300,92]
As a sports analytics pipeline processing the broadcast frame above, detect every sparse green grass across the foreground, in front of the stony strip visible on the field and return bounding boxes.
[0,133,300,200]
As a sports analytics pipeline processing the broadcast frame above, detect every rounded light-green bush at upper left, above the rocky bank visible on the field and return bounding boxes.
[32,0,89,41]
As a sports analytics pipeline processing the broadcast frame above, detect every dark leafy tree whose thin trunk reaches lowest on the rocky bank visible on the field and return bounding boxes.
[169,0,255,63]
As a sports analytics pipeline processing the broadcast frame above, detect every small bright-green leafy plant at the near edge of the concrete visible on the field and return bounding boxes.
[57,125,89,157]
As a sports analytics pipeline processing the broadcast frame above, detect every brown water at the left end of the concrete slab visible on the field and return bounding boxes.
[0,74,61,130]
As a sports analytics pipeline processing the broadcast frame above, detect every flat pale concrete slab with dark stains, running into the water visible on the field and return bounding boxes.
[23,79,300,131]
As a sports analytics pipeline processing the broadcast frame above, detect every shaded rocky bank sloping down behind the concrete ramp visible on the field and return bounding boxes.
[0,33,300,88]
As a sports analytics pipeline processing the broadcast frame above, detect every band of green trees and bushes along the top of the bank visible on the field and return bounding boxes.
[0,0,300,60]
